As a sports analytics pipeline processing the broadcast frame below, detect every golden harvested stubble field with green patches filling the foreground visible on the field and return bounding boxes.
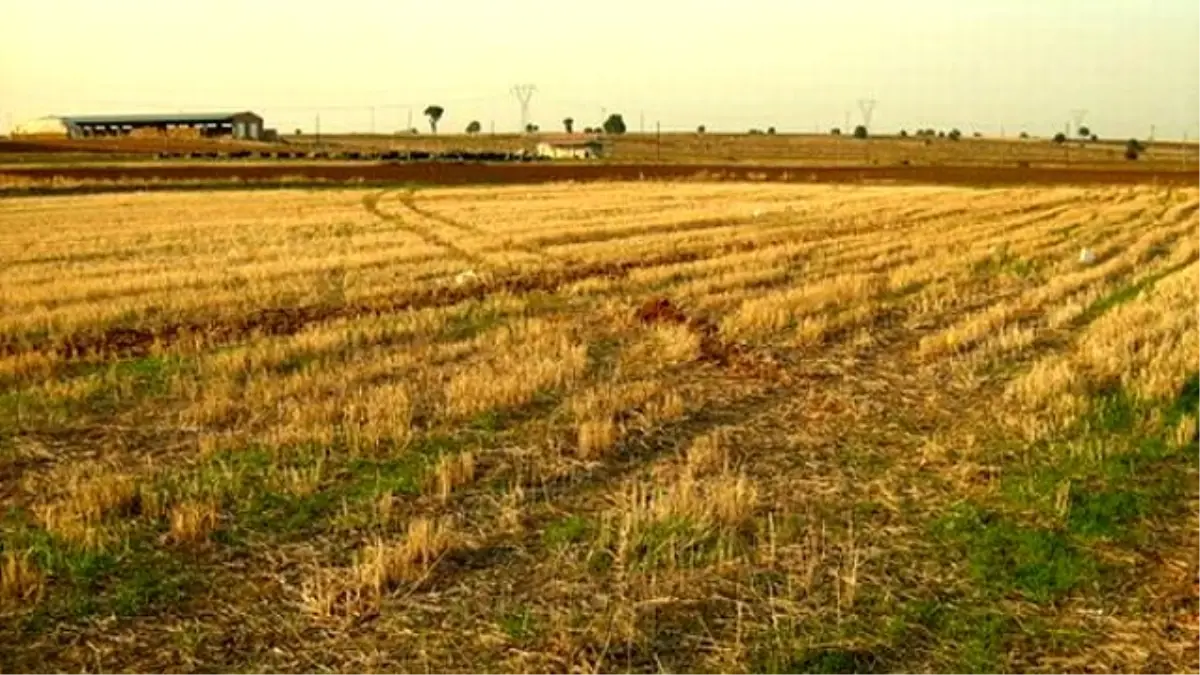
[0,181,1200,673]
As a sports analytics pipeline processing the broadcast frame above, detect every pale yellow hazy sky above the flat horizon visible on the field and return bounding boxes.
[0,0,1200,139]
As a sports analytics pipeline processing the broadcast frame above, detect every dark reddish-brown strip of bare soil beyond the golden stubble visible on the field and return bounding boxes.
[7,162,1200,186]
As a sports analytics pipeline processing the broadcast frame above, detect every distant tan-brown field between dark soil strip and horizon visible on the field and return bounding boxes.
[0,133,1200,171]
